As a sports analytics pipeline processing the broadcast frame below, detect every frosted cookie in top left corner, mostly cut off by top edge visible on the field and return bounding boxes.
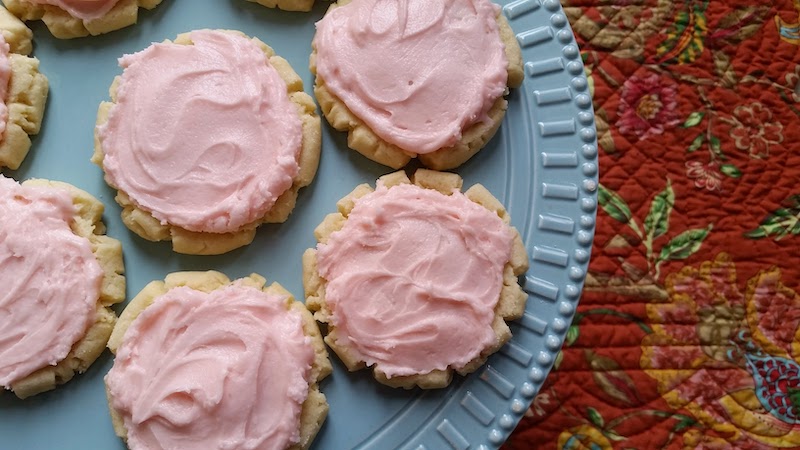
[3,0,161,39]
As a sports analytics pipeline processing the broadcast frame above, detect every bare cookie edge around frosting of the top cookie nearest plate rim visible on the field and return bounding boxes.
[309,0,524,170]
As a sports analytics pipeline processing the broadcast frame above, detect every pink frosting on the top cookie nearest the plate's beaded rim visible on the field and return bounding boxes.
[314,0,508,154]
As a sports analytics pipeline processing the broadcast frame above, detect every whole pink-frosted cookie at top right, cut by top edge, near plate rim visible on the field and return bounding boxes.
[310,0,523,170]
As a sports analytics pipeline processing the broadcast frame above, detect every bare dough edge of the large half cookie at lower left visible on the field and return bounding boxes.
[11,180,125,398]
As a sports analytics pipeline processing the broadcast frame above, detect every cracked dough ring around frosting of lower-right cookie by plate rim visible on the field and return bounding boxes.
[302,169,528,389]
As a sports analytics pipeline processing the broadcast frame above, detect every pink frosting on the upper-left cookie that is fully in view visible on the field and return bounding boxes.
[98,30,302,233]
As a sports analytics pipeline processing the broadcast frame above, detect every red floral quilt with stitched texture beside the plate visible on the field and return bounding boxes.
[504,0,800,450]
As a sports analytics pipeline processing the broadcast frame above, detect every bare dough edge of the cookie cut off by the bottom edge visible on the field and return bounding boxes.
[106,270,333,450]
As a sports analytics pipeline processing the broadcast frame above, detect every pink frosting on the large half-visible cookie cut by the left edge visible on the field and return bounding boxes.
[0,175,103,387]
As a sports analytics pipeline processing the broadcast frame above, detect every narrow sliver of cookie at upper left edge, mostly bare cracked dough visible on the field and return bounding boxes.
[0,6,49,169]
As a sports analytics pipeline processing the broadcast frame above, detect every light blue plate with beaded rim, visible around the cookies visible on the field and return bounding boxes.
[0,0,597,450]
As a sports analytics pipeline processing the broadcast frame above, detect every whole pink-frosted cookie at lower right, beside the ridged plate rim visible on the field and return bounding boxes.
[303,169,528,388]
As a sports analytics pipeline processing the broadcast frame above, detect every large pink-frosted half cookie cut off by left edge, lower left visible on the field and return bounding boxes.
[0,175,125,398]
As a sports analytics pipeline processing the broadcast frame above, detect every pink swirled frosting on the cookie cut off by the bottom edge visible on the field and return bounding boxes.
[106,284,314,450]
